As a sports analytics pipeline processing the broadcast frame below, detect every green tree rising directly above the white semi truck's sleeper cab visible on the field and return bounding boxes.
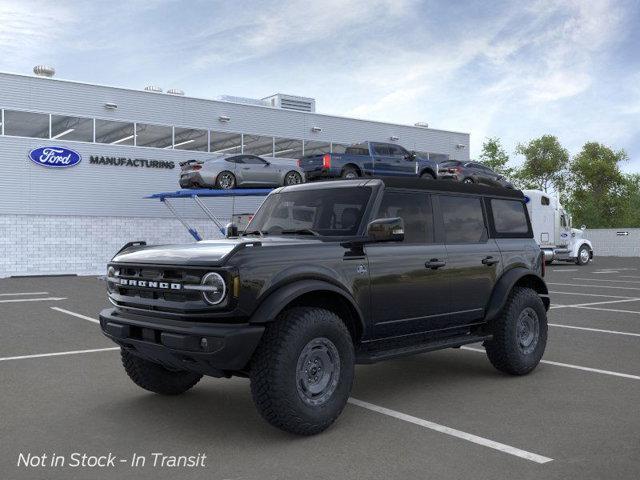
[515,135,569,194]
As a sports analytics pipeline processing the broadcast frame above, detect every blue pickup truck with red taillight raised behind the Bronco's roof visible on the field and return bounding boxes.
[298,142,438,181]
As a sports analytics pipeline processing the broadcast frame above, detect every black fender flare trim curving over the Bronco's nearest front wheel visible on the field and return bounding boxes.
[249,279,365,331]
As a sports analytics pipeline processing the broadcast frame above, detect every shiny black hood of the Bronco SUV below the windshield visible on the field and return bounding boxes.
[112,236,321,266]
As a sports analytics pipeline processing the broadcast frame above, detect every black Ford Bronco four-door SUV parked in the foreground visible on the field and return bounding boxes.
[100,178,549,435]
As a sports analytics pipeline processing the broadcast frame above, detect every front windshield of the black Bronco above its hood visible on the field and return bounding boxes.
[245,187,371,237]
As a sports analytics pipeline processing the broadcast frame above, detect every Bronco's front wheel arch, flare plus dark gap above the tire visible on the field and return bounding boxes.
[250,279,364,343]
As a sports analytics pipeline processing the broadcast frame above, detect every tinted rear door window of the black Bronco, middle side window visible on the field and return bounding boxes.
[440,195,486,243]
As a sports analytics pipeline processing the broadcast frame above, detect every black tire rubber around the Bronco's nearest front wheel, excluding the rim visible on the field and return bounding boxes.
[250,307,355,435]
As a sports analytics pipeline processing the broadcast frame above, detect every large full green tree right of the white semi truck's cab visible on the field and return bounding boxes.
[568,142,637,228]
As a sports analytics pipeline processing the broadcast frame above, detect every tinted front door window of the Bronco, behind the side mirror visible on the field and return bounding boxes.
[376,191,433,243]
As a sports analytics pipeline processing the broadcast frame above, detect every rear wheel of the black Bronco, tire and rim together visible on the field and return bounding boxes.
[485,287,547,375]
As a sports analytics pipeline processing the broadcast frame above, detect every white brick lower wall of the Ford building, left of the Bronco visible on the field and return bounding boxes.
[0,215,229,278]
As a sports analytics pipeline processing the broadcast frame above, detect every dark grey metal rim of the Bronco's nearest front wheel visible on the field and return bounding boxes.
[296,337,340,407]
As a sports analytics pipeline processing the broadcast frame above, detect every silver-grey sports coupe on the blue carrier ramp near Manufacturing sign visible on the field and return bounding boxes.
[180,154,305,190]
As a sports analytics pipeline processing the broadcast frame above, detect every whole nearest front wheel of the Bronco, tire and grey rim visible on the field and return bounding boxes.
[251,307,354,435]
